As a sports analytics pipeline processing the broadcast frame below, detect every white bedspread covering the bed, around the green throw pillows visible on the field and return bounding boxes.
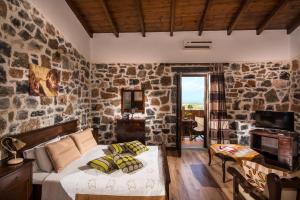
[34,145,165,200]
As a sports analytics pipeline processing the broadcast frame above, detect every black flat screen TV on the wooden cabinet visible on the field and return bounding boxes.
[254,111,294,131]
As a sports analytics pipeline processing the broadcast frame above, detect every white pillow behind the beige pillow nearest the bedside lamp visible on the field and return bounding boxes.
[34,136,60,172]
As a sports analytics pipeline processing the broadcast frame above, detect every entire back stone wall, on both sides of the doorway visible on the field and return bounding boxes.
[91,60,300,146]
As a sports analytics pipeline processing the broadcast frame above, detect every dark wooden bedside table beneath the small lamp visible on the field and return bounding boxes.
[0,160,32,200]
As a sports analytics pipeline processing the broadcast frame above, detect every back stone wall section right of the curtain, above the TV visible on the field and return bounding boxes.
[225,61,292,144]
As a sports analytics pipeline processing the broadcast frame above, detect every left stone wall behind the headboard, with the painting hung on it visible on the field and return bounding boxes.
[0,0,90,144]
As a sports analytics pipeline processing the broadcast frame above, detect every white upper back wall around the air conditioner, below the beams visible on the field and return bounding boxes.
[91,31,290,63]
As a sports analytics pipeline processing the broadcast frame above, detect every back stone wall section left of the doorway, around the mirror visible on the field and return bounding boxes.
[90,64,176,146]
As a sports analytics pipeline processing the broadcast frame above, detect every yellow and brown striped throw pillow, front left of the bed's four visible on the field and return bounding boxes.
[88,155,118,173]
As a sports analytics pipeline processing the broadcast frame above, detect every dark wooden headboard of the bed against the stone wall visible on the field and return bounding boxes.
[13,120,78,153]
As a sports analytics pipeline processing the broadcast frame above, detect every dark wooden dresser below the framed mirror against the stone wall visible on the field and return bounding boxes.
[115,119,146,143]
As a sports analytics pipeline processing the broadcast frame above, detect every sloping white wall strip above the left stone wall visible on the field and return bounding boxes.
[30,0,90,59]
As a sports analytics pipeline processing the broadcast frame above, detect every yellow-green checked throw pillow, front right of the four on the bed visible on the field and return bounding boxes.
[113,154,143,173]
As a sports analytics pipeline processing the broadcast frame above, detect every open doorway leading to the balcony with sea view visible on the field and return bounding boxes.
[177,74,207,152]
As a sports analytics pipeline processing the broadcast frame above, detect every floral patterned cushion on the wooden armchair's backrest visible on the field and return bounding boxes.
[242,160,289,191]
